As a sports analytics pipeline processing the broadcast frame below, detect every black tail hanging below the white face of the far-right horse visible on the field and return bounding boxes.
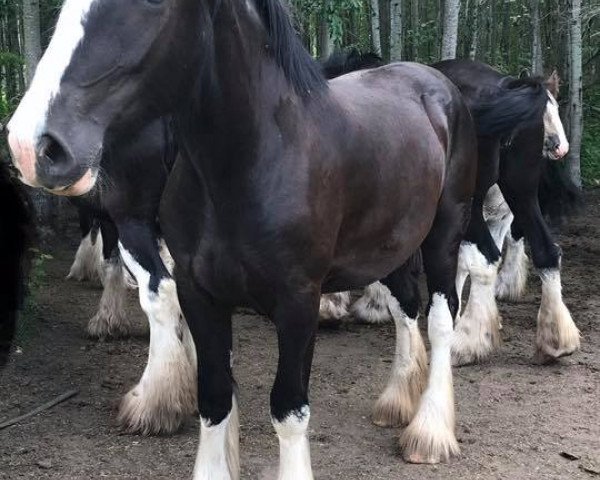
[538,159,584,226]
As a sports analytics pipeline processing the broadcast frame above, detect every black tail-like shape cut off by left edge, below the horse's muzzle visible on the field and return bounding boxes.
[0,162,32,367]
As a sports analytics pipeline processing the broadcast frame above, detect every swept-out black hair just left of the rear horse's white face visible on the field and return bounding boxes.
[470,78,548,137]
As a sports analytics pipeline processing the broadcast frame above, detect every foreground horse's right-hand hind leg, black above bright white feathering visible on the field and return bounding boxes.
[400,189,476,463]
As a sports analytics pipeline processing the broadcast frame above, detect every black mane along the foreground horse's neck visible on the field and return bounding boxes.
[254,0,327,96]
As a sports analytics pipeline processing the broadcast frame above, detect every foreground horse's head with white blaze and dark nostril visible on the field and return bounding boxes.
[7,0,212,195]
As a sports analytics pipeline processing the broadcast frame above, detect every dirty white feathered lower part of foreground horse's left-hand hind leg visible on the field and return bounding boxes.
[373,297,427,427]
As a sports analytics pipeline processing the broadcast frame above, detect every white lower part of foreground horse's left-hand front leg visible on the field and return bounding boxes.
[194,396,240,480]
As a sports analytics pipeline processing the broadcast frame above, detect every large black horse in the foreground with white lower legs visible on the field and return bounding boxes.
[9,0,488,479]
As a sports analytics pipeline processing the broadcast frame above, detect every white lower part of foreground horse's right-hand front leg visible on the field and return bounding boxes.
[273,405,313,480]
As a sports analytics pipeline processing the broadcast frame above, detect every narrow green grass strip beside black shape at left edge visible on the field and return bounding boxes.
[15,248,52,346]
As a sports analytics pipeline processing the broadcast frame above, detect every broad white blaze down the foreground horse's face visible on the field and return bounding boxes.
[7,0,97,186]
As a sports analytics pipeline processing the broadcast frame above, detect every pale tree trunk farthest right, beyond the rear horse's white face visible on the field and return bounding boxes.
[567,0,583,187]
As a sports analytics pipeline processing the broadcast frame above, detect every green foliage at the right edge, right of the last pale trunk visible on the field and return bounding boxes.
[581,85,600,187]
